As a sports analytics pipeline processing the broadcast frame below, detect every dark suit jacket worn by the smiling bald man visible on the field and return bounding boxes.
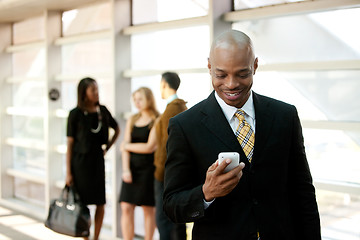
[164,92,321,240]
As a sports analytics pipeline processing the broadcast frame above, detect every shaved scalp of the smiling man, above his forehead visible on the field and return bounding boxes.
[210,30,255,59]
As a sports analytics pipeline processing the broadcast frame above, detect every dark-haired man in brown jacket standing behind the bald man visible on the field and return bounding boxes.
[124,72,187,240]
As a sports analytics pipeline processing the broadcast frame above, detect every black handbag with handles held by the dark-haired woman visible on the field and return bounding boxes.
[45,186,91,237]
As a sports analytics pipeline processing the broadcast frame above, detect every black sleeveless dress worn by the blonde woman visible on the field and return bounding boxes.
[119,125,155,206]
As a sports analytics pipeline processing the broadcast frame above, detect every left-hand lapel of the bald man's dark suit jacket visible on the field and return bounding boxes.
[201,91,241,151]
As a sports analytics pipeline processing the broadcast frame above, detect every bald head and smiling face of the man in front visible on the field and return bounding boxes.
[208,30,258,108]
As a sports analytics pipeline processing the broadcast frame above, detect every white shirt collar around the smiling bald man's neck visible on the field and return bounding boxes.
[215,91,255,122]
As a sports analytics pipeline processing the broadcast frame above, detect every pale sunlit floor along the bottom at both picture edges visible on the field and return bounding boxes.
[0,193,360,240]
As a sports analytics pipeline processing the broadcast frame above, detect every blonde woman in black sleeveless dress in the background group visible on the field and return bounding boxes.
[120,87,159,240]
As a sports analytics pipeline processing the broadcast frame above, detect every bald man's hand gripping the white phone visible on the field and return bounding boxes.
[202,159,245,202]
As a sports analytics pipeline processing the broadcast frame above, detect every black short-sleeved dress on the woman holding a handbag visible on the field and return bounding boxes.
[67,105,118,205]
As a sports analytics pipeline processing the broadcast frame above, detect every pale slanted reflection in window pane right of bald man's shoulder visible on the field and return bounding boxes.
[280,71,360,121]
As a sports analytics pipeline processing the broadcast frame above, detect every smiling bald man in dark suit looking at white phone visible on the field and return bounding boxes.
[164,30,321,240]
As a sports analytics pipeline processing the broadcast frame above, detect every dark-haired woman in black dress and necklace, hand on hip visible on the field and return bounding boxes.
[66,78,120,240]
